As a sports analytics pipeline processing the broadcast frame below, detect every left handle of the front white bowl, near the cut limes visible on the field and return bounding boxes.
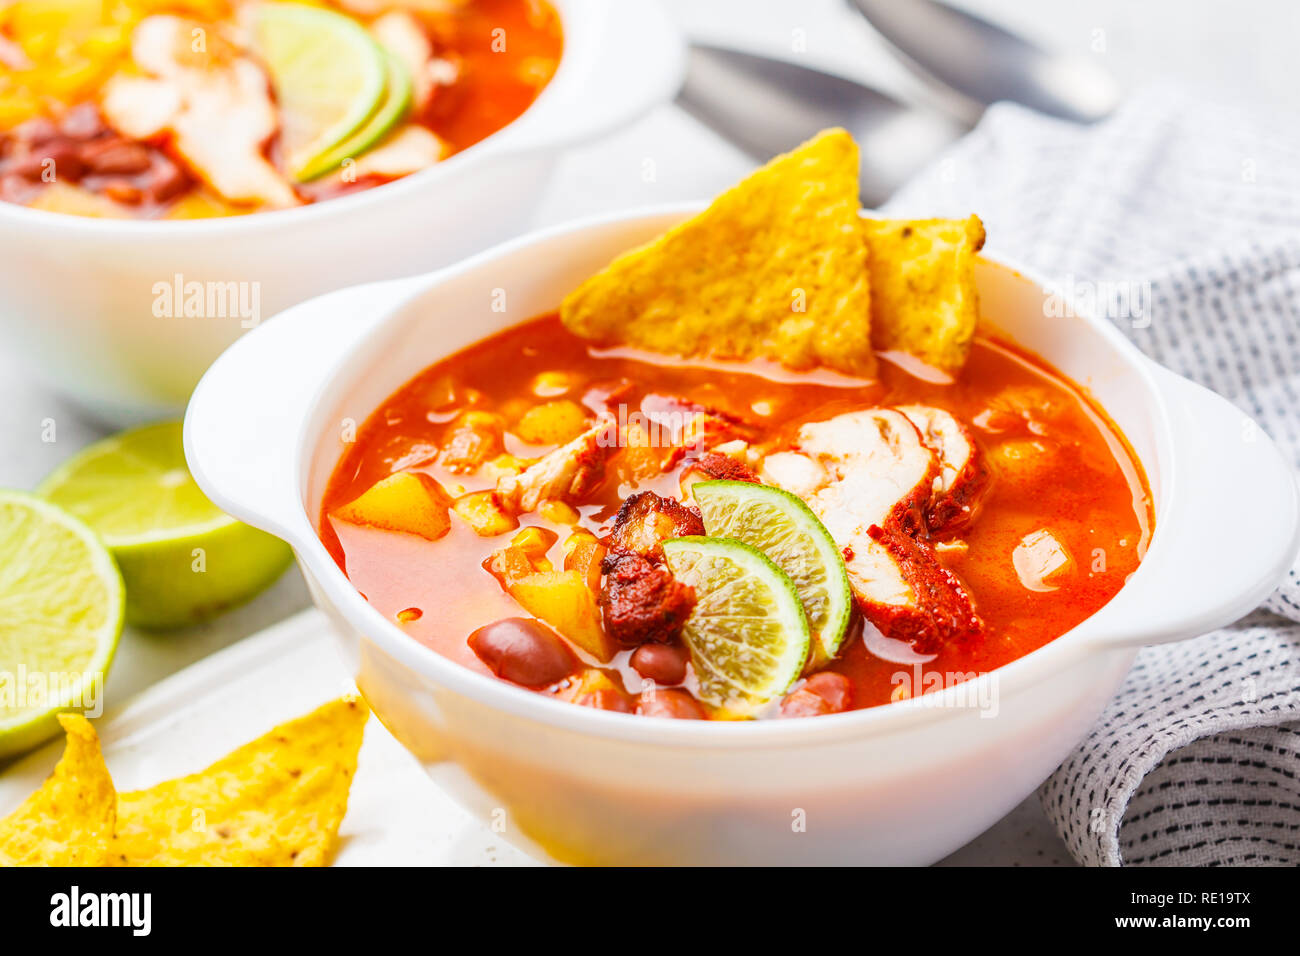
[185,278,419,544]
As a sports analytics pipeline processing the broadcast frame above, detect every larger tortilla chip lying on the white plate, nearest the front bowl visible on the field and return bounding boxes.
[114,697,369,866]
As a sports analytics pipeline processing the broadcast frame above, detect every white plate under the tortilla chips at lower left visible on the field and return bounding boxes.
[0,611,540,866]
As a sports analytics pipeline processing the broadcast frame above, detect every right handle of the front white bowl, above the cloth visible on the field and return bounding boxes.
[1080,368,1300,646]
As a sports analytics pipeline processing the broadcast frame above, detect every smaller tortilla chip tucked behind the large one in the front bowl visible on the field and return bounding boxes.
[863,216,984,375]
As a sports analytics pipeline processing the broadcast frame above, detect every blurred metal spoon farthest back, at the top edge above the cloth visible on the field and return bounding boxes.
[849,0,1119,122]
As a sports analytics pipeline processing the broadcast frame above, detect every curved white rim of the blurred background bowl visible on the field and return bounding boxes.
[0,0,613,242]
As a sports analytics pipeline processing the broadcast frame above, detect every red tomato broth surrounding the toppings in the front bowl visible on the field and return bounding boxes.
[320,315,1153,717]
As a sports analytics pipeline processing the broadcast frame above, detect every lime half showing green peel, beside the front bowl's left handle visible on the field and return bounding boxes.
[36,421,293,628]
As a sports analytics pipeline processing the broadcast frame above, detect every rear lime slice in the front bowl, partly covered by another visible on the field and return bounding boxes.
[690,481,853,659]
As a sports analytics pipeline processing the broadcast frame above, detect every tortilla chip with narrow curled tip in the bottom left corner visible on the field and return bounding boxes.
[0,714,117,866]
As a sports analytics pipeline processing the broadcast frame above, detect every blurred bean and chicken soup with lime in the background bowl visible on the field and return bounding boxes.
[0,0,563,220]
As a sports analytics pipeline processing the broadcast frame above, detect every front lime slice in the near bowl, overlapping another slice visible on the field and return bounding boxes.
[663,537,809,717]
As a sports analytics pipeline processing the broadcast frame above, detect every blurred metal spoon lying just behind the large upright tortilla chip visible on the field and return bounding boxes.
[677,44,969,207]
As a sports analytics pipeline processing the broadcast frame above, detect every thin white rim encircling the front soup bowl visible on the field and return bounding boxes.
[271,202,1177,748]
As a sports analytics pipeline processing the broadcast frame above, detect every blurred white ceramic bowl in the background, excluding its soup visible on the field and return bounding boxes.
[0,0,684,424]
